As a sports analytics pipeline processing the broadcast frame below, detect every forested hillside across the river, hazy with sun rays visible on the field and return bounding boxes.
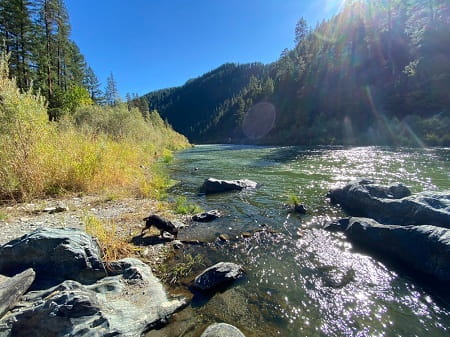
[145,0,450,146]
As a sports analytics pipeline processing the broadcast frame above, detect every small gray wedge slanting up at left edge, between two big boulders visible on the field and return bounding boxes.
[0,268,36,318]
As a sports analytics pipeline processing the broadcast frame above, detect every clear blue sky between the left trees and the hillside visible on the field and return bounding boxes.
[65,0,342,97]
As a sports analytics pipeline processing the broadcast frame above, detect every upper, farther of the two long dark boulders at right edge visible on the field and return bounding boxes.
[328,180,450,228]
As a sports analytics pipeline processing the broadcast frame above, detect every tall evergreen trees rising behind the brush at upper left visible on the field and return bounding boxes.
[0,0,101,120]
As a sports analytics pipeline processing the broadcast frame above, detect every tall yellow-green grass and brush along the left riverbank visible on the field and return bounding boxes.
[0,57,188,201]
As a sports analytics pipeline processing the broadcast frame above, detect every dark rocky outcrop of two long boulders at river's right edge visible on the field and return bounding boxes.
[325,179,450,284]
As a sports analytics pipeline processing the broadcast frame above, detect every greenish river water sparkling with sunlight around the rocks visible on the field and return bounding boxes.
[148,145,450,337]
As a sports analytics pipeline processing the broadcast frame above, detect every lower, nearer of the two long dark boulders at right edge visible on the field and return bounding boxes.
[325,218,450,282]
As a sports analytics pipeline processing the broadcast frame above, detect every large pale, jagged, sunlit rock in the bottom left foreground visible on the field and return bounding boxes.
[0,259,185,337]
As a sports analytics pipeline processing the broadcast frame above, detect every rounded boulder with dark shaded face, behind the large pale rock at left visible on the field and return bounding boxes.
[0,228,107,289]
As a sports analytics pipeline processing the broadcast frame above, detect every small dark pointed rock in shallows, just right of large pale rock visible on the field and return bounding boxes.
[194,262,244,290]
